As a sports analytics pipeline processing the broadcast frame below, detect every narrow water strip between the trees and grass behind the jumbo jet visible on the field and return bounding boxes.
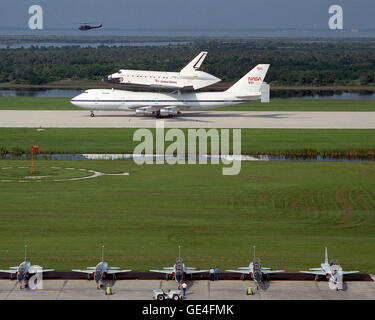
[0,88,375,100]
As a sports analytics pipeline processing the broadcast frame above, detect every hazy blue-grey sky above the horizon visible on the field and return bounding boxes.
[0,0,375,32]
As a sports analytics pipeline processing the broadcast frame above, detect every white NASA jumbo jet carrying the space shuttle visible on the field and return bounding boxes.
[71,64,270,117]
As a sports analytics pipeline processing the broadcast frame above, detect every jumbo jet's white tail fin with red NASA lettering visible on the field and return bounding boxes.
[227,64,270,97]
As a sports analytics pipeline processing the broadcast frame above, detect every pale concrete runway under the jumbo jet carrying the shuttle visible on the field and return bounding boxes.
[0,110,375,129]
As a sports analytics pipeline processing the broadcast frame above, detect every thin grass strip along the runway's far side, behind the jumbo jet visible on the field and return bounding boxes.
[0,97,375,111]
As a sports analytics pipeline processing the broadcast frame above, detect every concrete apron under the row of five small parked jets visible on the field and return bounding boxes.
[0,280,375,300]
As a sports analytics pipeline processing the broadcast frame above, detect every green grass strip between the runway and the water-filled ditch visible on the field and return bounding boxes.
[0,128,375,154]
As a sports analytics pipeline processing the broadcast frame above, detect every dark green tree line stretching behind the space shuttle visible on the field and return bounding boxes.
[0,39,375,86]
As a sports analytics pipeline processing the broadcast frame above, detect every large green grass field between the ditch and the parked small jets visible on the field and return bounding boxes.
[0,160,375,273]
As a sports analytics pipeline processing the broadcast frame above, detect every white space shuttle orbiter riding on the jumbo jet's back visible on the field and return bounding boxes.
[103,51,221,91]
